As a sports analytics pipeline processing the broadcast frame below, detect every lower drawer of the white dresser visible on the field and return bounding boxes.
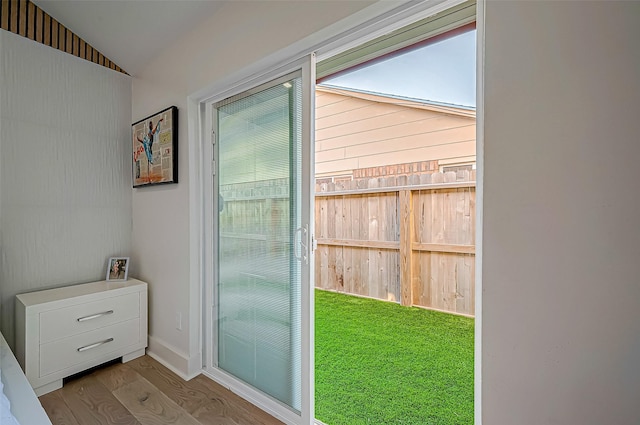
[40,319,140,377]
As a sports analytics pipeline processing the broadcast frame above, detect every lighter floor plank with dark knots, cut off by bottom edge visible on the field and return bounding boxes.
[113,378,201,425]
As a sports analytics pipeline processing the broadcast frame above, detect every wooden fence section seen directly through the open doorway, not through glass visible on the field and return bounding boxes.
[315,171,476,315]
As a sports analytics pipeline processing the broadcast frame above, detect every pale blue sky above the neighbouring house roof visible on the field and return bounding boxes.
[324,30,476,107]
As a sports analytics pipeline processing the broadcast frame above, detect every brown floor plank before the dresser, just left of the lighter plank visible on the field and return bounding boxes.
[59,375,140,425]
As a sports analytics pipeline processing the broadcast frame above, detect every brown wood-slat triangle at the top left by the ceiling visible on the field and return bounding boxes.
[0,0,129,75]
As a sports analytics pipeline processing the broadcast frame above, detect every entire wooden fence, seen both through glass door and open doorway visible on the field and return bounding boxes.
[220,171,476,315]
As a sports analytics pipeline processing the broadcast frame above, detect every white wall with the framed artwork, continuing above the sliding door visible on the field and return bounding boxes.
[133,0,373,375]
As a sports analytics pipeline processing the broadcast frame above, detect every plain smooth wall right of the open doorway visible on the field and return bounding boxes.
[482,1,640,425]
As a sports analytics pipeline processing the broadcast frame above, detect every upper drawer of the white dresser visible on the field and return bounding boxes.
[40,292,140,344]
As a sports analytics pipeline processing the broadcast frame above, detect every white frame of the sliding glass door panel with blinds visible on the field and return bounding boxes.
[202,54,315,425]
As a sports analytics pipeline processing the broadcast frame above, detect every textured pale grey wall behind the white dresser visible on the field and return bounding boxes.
[0,31,131,343]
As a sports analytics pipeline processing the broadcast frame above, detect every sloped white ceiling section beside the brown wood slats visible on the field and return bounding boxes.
[32,0,224,76]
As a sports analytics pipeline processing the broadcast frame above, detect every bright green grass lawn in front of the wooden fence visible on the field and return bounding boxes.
[315,290,474,425]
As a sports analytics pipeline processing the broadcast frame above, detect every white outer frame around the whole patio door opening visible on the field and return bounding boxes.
[187,0,486,424]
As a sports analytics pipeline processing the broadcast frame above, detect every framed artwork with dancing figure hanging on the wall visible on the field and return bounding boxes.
[131,106,178,187]
